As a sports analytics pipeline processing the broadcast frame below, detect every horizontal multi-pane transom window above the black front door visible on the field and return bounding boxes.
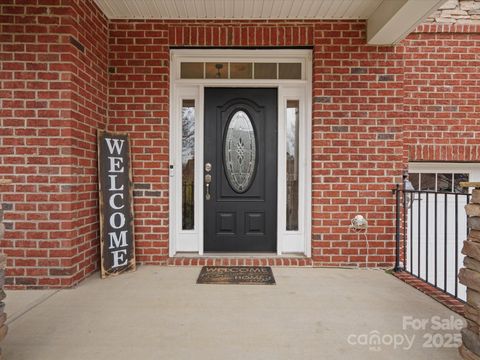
[180,61,304,80]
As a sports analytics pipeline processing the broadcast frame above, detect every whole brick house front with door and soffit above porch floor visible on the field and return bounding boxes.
[0,0,480,288]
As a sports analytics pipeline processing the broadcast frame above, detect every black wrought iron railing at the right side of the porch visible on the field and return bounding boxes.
[394,186,470,301]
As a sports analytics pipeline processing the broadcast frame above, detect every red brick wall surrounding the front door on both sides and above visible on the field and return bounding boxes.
[109,21,403,266]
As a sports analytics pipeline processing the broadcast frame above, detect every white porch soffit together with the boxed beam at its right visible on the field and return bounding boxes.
[95,0,445,45]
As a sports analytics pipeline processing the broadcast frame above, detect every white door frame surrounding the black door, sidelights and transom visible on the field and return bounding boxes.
[169,49,312,257]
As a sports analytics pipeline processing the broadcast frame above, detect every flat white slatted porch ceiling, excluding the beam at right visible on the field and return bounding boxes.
[95,0,383,20]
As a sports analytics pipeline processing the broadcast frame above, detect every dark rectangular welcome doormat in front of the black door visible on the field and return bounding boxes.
[197,266,275,285]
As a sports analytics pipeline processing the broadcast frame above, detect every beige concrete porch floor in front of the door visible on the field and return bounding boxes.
[1,266,463,360]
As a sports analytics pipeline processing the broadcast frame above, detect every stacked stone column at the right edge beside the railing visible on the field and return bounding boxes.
[459,187,480,360]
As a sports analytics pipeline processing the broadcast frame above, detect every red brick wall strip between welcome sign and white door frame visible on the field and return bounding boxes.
[109,22,169,263]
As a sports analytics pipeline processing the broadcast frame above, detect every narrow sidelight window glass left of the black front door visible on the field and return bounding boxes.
[182,100,195,230]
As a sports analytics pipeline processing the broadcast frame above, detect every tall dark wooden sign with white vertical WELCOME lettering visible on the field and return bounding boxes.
[98,131,136,278]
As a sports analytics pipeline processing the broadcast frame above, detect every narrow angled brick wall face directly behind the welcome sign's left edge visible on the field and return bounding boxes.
[69,0,108,283]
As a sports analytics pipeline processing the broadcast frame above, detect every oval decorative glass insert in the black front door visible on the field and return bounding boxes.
[223,111,257,193]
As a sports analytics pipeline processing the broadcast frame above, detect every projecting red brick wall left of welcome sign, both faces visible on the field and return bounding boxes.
[0,0,108,287]
